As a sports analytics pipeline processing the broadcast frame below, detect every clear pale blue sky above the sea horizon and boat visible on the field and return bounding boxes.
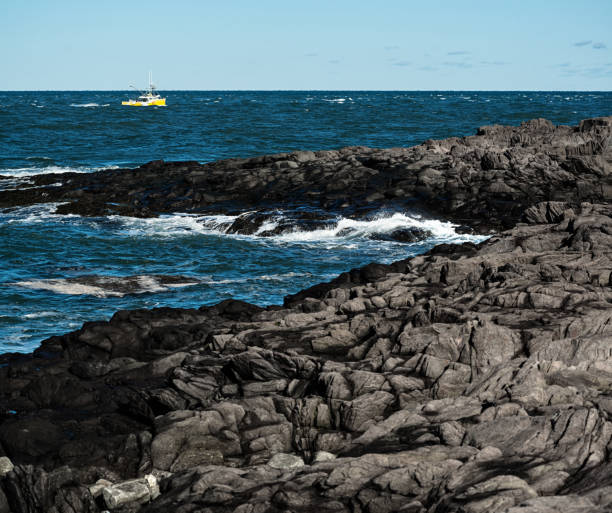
[0,0,612,91]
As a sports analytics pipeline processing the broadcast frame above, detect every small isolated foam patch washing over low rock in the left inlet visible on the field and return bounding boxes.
[14,275,200,298]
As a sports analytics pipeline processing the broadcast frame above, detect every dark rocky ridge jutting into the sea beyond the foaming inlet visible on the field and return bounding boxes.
[0,117,612,234]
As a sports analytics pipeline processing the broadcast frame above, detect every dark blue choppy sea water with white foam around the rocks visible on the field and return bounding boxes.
[0,91,612,352]
